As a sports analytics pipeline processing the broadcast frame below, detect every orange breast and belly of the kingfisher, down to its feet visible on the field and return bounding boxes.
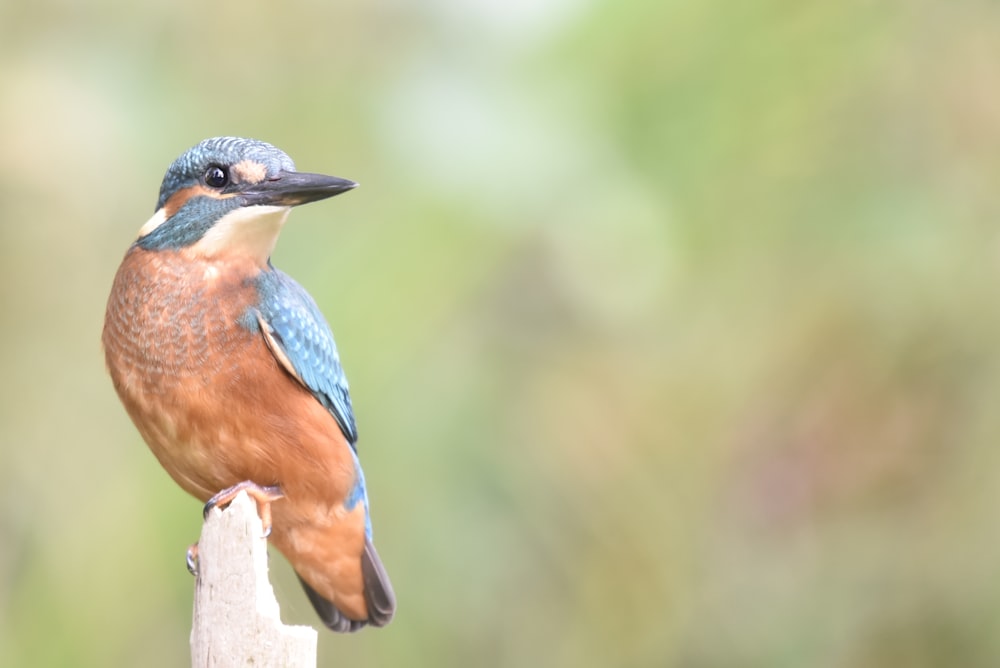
[103,248,355,508]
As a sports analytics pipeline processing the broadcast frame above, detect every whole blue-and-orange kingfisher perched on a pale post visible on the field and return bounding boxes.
[102,137,396,632]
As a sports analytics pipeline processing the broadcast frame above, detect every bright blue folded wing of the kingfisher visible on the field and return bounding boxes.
[247,268,358,450]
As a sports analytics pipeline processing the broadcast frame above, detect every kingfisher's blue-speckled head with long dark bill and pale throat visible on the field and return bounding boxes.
[136,137,358,266]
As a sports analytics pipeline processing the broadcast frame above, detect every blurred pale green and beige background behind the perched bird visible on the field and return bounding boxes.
[0,0,1000,668]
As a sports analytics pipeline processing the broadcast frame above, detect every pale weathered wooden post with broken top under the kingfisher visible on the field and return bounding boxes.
[191,492,316,668]
